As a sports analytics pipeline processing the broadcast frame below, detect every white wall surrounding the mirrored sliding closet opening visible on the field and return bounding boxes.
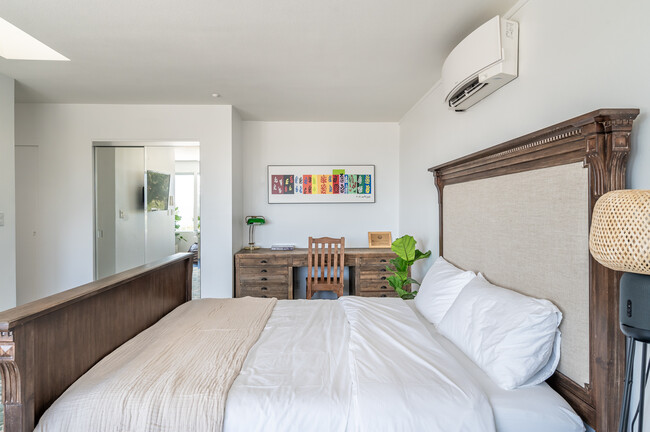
[15,104,233,297]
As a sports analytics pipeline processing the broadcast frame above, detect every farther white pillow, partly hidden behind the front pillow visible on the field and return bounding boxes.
[415,257,476,324]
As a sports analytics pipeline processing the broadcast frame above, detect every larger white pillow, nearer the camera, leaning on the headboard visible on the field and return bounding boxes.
[438,277,562,390]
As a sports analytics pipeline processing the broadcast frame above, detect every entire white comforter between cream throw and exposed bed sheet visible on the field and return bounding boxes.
[224,297,494,432]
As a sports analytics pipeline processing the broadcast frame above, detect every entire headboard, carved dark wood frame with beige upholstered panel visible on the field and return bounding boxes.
[429,109,639,432]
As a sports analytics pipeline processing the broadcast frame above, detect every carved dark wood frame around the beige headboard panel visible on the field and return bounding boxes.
[429,109,639,431]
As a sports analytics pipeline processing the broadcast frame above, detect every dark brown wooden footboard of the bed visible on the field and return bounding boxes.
[0,253,192,432]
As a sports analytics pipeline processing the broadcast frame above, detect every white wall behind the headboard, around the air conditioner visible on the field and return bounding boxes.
[399,0,650,279]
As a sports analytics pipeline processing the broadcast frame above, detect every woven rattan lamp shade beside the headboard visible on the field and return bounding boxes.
[589,189,650,274]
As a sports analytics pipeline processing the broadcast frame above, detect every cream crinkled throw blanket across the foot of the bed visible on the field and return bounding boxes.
[36,297,277,432]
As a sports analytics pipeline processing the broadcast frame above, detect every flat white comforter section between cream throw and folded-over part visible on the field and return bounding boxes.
[224,300,351,432]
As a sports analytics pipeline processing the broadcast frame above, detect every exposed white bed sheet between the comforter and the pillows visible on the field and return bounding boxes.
[406,300,585,432]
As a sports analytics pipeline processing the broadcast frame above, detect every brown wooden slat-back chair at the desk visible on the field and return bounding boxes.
[307,237,345,300]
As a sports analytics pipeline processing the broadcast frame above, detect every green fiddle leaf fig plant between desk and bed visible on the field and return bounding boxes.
[386,235,431,300]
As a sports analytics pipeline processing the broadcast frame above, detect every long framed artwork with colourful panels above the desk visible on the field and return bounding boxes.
[268,165,375,204]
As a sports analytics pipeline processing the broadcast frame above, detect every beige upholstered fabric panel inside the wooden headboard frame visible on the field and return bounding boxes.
[443,163,589,384]
